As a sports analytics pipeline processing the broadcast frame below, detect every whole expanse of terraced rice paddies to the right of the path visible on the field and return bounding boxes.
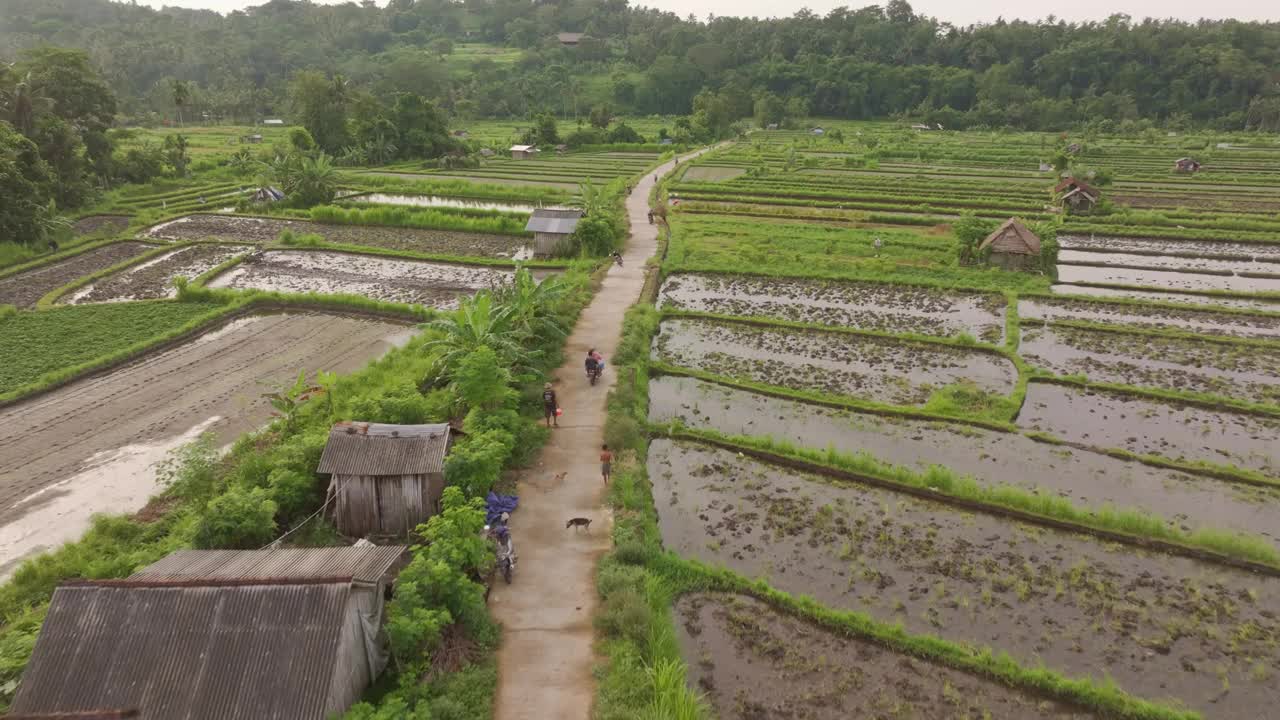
[616,122,1280,719]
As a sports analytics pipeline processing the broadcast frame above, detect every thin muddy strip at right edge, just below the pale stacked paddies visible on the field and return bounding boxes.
[1018,297,1280,338]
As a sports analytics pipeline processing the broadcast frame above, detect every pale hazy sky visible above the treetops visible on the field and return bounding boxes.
[140,0,1280,24]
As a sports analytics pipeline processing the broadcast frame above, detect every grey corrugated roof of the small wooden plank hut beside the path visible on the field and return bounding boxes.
[316,423,449,475]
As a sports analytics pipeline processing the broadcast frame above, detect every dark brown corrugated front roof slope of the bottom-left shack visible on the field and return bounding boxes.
[10,583,351,720]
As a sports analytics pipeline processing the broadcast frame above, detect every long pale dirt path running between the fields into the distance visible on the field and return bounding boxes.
[489,148,716,720]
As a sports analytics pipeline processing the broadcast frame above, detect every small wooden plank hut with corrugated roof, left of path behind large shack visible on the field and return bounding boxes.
[316,421,452,537]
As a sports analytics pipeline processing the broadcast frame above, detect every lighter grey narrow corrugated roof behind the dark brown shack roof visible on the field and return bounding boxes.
[129,544,408,583]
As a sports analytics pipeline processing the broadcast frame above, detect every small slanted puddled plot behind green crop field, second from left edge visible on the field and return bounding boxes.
[64,245,252,305]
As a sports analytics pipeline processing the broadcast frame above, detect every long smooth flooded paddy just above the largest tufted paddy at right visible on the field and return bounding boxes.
[649,377,1280,542]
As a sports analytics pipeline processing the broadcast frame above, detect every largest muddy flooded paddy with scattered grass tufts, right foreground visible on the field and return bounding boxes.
[648,439,1280,720]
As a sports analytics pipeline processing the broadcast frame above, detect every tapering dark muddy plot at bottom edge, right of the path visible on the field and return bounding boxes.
[676,593,1093,720]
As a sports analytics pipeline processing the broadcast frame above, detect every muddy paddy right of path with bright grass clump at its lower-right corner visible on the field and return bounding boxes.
[653,319,1016,405]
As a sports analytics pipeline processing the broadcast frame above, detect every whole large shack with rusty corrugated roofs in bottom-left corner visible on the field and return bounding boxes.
[10,547,406,720]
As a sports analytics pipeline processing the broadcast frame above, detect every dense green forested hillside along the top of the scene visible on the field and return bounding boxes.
[0,0,1280,131]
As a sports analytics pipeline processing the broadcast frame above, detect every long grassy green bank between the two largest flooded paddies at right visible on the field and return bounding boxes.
[655,427,1280,577]
